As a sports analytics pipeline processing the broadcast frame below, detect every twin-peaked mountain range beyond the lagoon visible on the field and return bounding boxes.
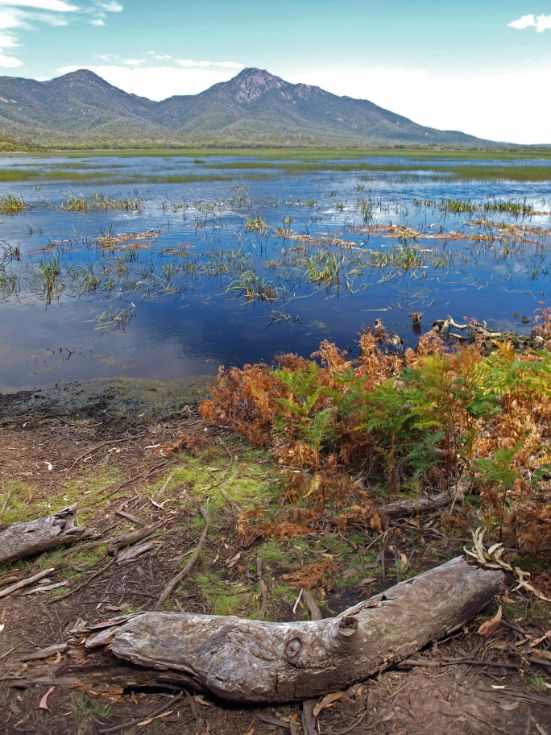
[0,69,498,147]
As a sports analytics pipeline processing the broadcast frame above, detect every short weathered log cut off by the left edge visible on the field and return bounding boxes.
[0,505,86,564]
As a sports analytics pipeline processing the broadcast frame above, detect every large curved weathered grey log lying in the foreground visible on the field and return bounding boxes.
[79,557,504,703]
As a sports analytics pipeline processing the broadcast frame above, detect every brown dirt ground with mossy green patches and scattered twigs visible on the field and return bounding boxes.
[0,385,551,735]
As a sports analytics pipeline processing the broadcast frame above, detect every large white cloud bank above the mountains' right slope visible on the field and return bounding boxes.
[281,64,551,144]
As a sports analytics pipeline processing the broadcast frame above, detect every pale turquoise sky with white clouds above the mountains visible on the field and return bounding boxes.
[0,0,551,143]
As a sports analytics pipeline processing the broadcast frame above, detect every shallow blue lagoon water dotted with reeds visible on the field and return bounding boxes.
[0,155,551,388]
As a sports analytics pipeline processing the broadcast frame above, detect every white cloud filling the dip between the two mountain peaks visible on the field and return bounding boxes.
[58,62,243,100]
